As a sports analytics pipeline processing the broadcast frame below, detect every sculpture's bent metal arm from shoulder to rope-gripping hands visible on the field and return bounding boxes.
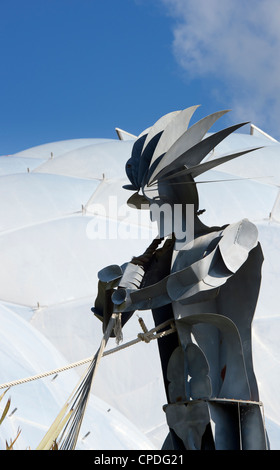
[92,219,258,321]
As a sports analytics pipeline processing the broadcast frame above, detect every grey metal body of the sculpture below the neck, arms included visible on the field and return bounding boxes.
[96,219,267,450]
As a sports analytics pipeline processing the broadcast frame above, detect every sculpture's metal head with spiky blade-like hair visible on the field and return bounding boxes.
[124,106,262,241]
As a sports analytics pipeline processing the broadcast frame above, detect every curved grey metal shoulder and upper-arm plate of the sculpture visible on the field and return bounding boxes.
[167,219,258,304]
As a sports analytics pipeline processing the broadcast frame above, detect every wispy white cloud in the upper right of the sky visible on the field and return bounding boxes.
[161,0,280,138]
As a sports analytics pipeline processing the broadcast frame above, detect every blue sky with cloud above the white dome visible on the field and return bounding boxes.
[0,0,280,155]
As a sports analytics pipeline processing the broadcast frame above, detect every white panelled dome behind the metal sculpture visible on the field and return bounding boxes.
[0,134,280,449]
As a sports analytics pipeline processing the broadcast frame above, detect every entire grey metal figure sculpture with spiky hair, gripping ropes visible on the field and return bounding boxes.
[93,106,268,450]
